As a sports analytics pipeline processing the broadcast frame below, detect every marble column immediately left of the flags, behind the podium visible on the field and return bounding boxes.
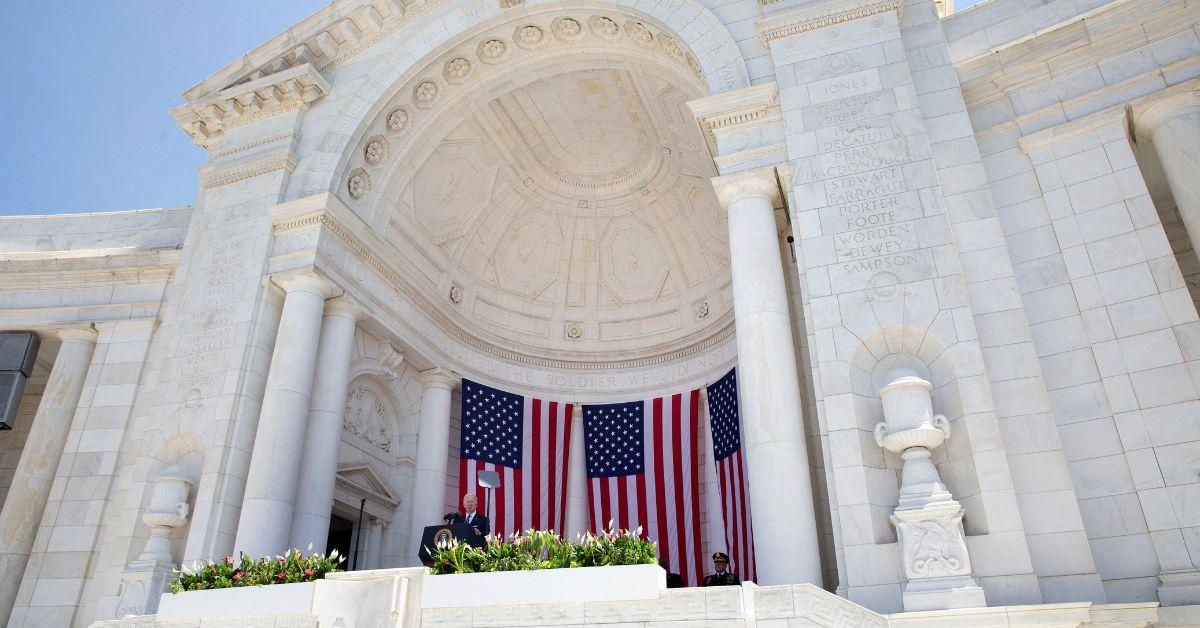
[409,369,458,564]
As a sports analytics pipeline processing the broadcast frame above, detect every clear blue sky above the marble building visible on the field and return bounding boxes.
[0,0,974,215]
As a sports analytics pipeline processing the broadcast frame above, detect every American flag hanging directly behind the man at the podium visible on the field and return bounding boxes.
[458,379,571,536]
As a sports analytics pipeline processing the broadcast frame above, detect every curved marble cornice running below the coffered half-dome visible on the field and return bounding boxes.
[269,195,734,371]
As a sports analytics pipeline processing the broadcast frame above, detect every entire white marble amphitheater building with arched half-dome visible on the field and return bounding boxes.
[0,0,1200,628]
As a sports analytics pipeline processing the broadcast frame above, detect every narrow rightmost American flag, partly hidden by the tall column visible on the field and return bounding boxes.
[708,369,757,580]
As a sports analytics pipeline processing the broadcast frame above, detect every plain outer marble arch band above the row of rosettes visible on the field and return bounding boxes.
[288,0,750,198]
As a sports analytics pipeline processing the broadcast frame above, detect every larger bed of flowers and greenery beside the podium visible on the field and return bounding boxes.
[430,522,658,574]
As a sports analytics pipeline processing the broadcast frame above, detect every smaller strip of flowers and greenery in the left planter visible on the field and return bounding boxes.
[170,545,346,593]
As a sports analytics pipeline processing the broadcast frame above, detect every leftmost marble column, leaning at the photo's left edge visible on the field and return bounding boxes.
[0,328,96,626]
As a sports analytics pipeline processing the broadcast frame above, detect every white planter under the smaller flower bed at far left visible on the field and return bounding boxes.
[158,582,317,621]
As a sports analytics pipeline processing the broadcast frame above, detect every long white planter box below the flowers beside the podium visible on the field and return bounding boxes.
[421,564,667,609]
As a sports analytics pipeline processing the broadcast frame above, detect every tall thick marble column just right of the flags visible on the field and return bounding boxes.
[713,167,822,586]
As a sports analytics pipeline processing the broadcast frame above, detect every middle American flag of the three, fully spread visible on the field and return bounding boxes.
[583,390,704,586]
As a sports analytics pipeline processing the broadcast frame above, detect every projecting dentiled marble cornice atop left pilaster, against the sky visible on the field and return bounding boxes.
[170,64,331,148]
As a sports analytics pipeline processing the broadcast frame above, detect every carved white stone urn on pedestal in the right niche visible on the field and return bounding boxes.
[875,371,988,611]
